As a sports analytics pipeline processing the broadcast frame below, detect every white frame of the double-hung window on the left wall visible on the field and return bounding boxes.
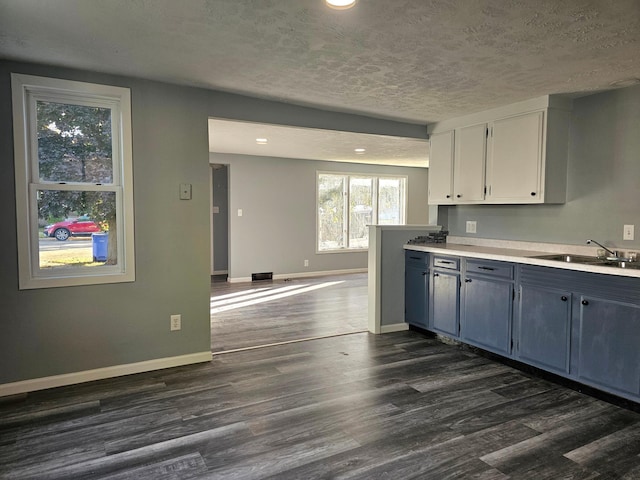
[11,73,135,290]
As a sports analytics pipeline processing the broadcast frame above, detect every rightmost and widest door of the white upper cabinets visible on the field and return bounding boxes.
[487,112,544,203]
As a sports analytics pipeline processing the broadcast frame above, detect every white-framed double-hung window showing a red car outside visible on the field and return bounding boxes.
[11,74,135,289]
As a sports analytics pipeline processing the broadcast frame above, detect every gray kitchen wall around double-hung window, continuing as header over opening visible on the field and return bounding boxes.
[0,61,426,383]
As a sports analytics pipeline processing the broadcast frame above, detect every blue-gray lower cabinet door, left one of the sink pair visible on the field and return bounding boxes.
[516,284,571,374]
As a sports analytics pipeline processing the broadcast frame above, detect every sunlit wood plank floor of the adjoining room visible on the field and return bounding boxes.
[211,273,367,352]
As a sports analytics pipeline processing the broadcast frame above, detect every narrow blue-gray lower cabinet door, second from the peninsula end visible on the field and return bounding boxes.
[430,271,460,337]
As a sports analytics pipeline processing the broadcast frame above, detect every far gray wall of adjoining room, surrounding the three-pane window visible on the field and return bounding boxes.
[210,153,427,279]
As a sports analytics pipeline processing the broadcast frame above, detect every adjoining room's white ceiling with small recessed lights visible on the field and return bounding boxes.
[209,118,429,168]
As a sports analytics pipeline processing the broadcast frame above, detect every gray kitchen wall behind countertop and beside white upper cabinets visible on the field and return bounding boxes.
[439,86,640,249]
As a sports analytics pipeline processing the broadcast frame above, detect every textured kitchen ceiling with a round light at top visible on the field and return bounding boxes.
[0,0,640,166]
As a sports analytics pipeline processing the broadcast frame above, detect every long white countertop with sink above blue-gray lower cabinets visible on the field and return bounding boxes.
[404,241,640,278]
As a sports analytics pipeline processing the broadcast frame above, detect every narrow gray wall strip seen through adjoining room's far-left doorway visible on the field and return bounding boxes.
[212,165,229,272]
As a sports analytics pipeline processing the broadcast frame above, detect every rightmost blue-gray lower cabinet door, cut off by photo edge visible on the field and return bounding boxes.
[578,296,640,396]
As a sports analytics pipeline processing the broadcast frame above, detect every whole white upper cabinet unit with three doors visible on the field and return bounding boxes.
[429,96,571,204]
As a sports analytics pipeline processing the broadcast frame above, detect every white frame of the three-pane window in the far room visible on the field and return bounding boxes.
[315,170,409,254]
